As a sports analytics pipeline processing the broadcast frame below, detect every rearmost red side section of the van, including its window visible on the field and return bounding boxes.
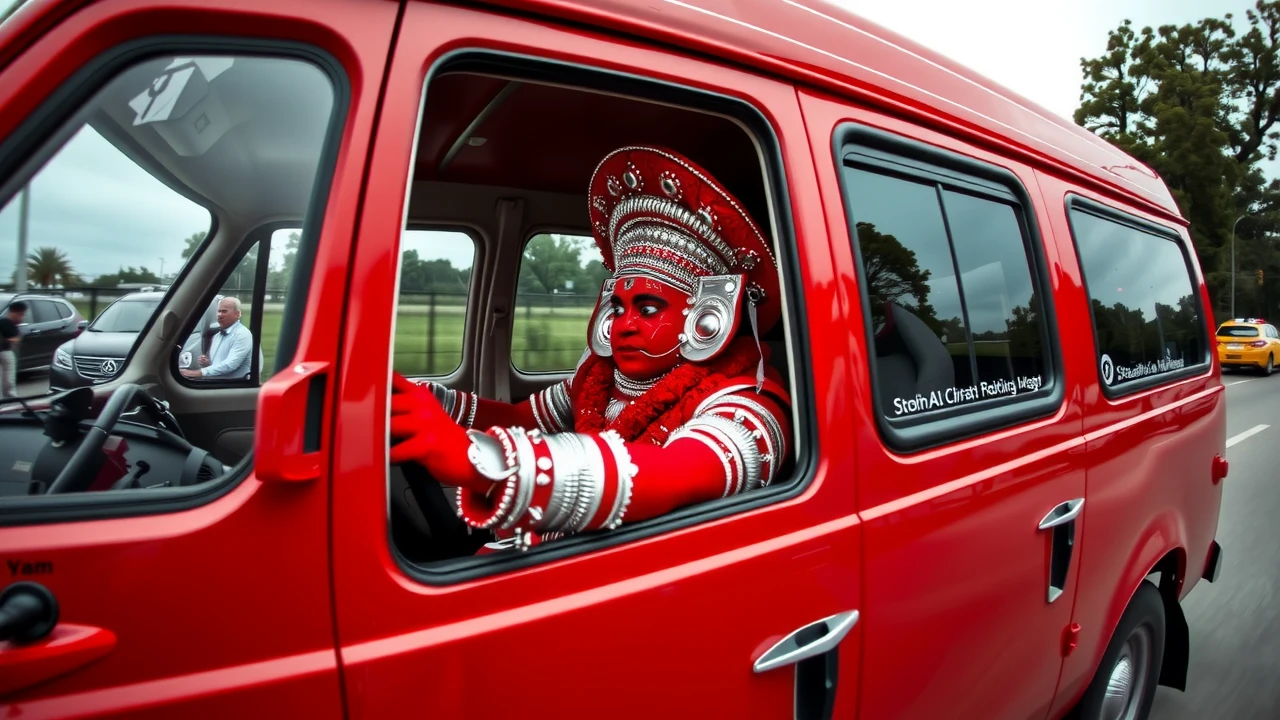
[1038,173,1226,708]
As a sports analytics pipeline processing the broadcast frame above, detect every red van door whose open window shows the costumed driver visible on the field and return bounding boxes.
[333,3,860,719]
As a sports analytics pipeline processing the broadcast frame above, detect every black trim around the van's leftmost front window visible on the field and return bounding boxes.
[0,33,352,528]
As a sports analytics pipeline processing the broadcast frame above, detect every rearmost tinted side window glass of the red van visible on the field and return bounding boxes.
[1071,209,1203,388]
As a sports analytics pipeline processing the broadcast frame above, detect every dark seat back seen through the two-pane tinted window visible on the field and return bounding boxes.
[876,302,956,398]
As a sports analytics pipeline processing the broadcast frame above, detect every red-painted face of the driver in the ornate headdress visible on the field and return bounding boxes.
[609,275,689,380]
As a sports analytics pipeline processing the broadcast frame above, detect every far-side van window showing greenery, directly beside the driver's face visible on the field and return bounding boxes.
[511,233,609,373]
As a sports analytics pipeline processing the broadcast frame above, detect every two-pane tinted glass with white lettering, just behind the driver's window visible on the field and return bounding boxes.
[844,158,1048,423]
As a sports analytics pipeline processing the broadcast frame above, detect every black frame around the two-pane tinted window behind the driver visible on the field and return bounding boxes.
[832,122,1066,454]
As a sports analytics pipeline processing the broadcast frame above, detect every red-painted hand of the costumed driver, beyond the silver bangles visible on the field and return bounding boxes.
[390,373,490,492]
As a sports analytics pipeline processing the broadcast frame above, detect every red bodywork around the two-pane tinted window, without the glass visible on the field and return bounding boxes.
[800,91,1088,719]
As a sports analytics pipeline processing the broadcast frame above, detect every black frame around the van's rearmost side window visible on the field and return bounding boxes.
[1064,192,1216,400]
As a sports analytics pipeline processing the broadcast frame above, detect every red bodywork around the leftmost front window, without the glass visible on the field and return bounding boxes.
[0,0,396,717]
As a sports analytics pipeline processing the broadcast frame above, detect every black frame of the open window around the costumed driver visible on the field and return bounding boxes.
[384,47,820,587]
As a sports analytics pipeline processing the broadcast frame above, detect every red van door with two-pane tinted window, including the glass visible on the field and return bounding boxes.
[801,92,1087,720]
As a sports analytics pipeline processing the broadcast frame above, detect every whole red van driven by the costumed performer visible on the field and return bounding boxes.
[0,0,1226,720]
